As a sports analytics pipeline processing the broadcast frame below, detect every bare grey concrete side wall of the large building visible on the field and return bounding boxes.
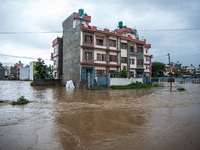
[62,14,81,87]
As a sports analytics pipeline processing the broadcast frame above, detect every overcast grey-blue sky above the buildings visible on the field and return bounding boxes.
[0,0,200,67]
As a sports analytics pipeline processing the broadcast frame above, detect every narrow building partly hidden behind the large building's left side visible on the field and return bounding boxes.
[51,37,63,79]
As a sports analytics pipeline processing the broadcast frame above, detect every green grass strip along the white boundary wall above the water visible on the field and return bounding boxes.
[111,82,155,90]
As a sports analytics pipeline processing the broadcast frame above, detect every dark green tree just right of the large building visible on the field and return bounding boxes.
[152,62,166,77]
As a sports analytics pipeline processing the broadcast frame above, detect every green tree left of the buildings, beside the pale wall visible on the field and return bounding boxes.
[35,58,47,79]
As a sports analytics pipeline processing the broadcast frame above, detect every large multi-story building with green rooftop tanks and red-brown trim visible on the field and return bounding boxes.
[63,9,152,87]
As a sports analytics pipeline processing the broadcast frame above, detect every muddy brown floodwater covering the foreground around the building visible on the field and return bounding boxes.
[0,81,200,150]
